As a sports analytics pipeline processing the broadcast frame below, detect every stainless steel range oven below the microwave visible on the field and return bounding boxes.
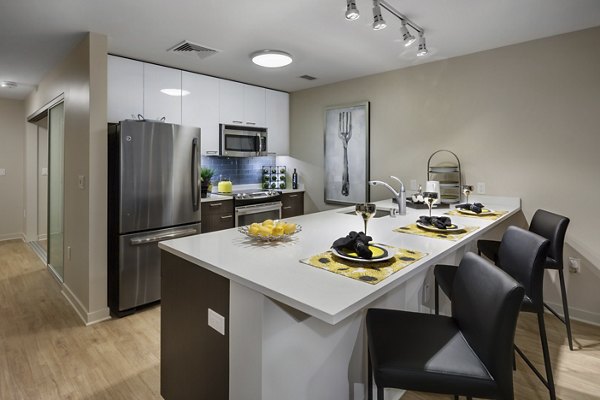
[233,190,282,226]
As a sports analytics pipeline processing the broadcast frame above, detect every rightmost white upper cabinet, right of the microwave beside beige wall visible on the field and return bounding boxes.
[266,89,290,156]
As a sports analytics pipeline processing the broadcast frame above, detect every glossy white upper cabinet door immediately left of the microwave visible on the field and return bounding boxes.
[181,71,219,155]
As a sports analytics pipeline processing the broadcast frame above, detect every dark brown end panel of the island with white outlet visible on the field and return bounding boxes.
[160,251,229,400]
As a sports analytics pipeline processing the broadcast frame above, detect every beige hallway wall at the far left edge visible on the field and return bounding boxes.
[0,99,25,240]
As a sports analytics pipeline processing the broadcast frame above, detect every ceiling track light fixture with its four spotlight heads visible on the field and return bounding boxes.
[346,0,428,57]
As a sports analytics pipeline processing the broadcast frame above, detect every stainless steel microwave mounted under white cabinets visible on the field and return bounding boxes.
[219,124,267,157]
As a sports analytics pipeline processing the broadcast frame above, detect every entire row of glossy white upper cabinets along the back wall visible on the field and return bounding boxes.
[108,55,290,155]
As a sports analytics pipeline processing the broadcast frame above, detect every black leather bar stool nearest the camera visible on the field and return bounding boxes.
[366,253,524,400]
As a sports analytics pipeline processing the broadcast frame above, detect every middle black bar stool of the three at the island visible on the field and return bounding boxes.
[433,226,556,400]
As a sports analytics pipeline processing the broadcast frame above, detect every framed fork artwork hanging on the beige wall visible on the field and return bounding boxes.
[325,101,370,204]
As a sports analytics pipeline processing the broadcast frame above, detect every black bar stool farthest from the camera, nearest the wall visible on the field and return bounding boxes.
[477,210,573,350]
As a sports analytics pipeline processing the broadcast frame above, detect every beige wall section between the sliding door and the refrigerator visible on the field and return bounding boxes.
[26,33,108,322]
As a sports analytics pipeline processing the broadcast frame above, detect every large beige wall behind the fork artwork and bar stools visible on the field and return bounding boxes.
[290,28,600,323]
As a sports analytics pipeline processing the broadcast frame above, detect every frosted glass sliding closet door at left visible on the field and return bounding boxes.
[48,103,65,281]
